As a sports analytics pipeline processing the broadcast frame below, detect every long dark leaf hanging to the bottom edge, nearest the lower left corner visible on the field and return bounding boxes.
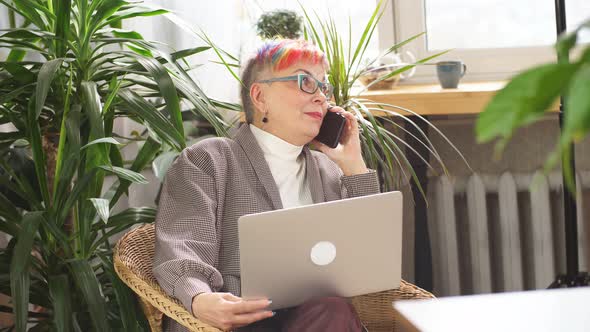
[10,212,43,331]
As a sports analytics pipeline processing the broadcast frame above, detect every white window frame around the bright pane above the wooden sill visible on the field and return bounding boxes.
[379,0,555,84]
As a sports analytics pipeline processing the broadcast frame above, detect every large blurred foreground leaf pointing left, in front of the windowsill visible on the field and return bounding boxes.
[476,64,577,147]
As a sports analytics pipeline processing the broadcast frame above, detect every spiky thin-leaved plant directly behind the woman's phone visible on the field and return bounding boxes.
[301,0,465,197]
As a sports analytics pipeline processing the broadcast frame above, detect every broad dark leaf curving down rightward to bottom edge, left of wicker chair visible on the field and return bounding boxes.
[69,260,111,332]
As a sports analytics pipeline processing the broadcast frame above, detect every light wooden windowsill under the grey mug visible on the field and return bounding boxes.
[361,81,557,115]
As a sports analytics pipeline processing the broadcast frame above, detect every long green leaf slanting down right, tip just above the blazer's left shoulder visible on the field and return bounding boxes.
[118,89,184,150]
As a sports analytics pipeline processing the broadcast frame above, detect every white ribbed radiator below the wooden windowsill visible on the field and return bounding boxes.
[428,172,590,296]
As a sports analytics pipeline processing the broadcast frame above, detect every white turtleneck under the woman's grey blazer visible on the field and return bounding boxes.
[250,124,313,208]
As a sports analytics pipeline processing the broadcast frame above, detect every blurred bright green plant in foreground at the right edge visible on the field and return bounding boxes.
[476,19,590,189]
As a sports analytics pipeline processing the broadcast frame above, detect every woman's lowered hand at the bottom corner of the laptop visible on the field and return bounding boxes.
[192,293,274,331]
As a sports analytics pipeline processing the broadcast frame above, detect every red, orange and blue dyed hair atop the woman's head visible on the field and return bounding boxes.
[255,39,327,71]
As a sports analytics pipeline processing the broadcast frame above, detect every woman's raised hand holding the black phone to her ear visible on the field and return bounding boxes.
[312,106,368,176]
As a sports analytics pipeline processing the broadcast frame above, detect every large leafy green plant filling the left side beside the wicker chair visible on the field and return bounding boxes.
[0,0,227,332]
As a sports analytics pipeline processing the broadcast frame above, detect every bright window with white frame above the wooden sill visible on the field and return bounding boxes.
[394,0,590,82]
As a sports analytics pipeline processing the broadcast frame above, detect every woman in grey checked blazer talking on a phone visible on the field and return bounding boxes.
[154,40,379,331]
